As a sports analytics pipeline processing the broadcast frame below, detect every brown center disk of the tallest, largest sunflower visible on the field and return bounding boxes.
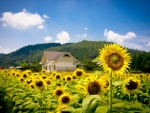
[106,53,124,70]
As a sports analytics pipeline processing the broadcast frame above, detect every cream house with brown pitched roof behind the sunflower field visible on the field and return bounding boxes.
[40,51,80,72]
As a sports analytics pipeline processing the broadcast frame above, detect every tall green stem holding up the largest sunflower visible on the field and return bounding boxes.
[109,72,112,113]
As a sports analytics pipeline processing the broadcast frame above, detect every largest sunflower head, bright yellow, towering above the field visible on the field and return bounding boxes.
[99,44,131,74]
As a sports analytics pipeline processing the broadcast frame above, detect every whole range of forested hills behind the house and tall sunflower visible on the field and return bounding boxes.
[0,40,146,67]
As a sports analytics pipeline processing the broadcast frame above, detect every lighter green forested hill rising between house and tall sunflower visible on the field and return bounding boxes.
[47,40,144,61]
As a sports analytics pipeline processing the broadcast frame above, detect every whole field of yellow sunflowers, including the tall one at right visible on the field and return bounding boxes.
[0,44,150,113]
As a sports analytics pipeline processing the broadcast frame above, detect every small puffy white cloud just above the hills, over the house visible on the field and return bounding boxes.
[55,31,70,44]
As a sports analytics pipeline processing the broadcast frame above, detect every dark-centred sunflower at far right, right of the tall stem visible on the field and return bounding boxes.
[123,77,141,94]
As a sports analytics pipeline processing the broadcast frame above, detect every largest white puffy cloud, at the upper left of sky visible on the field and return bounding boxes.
[0,9,45,29]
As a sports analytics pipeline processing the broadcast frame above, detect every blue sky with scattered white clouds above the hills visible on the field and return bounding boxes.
[0,0,150,53]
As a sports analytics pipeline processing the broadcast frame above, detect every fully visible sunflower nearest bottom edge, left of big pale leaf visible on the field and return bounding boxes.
[58,93,73,105]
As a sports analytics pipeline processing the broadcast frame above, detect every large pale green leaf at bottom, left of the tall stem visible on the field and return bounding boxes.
[82,95,100,113]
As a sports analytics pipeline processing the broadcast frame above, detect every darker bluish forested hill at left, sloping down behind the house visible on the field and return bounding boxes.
[0,43,61,67]
